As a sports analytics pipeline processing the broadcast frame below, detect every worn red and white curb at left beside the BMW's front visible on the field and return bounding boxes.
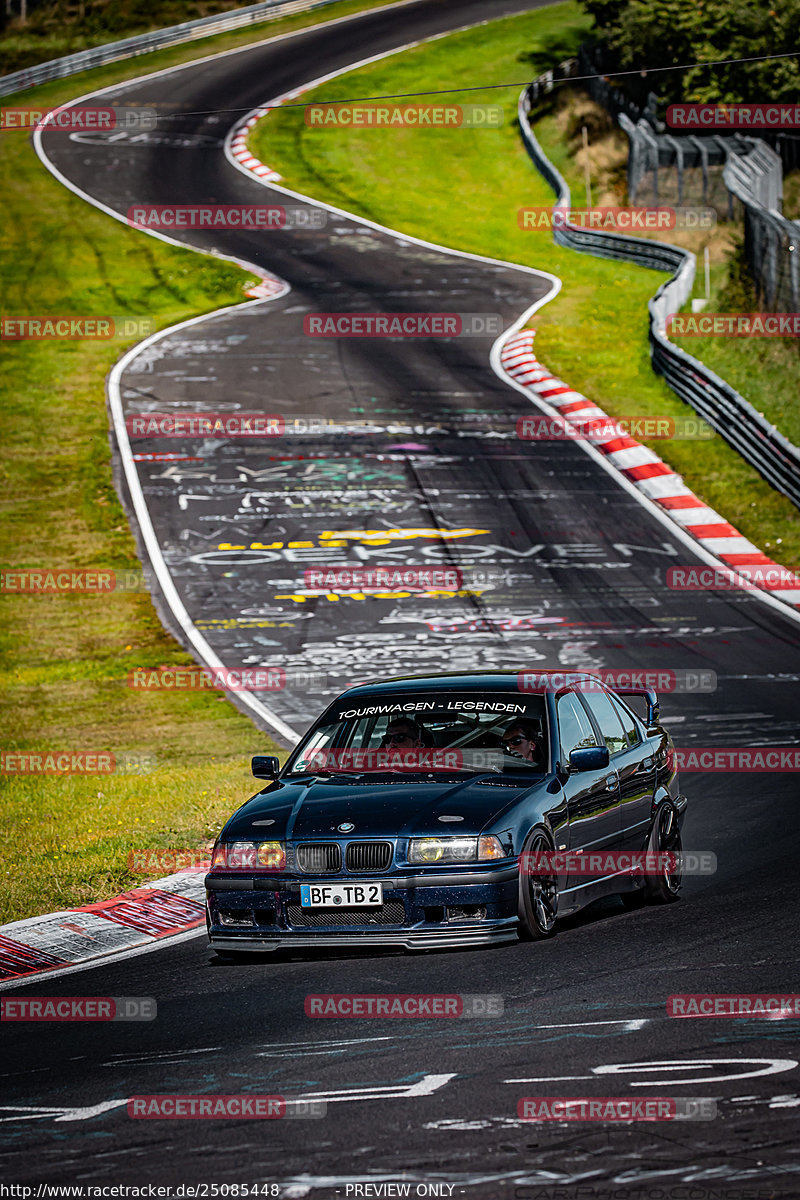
[0,864,210,990]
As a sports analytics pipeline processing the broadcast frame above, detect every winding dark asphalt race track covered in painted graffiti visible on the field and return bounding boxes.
[6,0,800,1200]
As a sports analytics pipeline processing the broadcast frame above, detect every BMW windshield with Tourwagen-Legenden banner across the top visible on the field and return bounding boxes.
[285,691,548,775]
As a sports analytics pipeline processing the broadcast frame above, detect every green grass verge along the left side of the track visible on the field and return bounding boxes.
[0,2,400,922]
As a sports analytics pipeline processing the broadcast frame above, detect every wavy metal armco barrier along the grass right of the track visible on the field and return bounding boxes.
[518,85,800,508]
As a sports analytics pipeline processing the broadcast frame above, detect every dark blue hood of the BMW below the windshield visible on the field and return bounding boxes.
[222,776,545,841]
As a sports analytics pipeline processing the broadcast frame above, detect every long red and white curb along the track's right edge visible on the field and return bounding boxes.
[500,329,800,606]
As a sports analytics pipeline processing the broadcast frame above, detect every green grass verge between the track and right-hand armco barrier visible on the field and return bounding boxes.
[251,2,800,569]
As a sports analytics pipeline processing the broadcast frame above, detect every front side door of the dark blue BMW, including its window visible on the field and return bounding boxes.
[555,691,621,889]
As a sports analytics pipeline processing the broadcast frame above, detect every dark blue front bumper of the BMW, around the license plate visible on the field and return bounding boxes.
[205,863,519,950]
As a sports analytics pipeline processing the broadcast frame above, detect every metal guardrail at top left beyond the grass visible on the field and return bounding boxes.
[0,0,335,96]
